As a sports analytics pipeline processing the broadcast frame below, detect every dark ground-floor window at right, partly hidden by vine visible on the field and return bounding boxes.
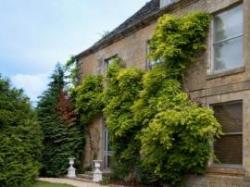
[212,101,242,165]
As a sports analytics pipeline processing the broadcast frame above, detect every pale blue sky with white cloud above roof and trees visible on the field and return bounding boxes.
[0,0,148,102]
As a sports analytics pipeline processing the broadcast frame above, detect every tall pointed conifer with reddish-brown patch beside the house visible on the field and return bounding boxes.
[37,65,83,176]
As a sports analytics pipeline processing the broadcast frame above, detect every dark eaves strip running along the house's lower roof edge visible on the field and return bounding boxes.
[75,0,194,61]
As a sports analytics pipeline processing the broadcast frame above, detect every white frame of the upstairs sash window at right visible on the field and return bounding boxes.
[210,4,245,74]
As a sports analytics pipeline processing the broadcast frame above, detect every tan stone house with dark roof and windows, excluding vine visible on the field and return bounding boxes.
[76,0,250,187]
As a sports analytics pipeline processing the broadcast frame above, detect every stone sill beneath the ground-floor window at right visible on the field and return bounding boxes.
[207,164,244,176]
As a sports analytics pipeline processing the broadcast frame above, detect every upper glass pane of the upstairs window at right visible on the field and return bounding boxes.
[214,6,243,42]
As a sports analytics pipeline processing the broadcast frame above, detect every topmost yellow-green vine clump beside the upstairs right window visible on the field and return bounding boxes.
[149,12,210,78]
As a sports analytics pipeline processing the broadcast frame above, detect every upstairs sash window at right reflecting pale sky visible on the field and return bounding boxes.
[212,5,243,73]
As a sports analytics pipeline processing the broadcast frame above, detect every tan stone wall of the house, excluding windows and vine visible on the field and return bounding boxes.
[79,0,250,184]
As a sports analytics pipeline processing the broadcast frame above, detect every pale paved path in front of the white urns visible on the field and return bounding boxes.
[38,178,108,187]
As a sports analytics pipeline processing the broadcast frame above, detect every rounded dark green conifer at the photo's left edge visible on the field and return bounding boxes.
[0,77,42,187]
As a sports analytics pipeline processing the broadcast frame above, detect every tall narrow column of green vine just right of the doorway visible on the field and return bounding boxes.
[104,58,143,180]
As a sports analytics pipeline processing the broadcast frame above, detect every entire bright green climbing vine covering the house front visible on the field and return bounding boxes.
[76,12,221,186]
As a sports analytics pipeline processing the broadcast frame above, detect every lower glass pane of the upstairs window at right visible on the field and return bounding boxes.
[214,37,243,71]
